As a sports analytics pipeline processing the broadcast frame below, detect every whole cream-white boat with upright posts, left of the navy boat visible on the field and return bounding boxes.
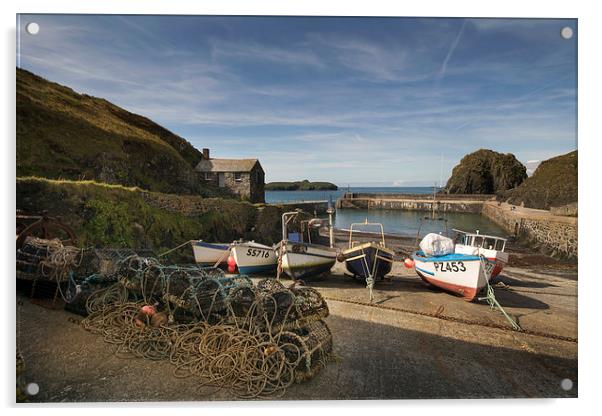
[275,212,337,279]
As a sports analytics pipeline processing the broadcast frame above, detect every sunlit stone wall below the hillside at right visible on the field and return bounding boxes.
[482,201,578,259]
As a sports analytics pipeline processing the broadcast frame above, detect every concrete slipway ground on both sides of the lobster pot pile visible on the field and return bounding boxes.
[18,263,578,402]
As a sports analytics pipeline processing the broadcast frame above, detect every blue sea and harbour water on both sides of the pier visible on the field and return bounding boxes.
[265,187,507,237]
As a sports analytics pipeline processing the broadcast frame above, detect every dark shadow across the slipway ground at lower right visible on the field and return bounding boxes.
[285,309,577,400]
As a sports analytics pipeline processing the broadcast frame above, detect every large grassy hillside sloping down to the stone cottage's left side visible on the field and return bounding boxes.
[17,69,214,195]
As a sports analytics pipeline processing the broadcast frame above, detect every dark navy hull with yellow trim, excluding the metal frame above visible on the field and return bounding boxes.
[342,243,394,280]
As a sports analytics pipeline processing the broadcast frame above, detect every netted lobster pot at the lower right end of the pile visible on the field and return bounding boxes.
[279,320,332,383]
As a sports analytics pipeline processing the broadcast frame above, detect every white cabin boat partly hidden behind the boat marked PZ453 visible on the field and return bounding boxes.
[453,229,508,278]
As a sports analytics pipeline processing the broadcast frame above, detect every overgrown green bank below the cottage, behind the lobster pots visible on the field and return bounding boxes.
[17,177,282,260]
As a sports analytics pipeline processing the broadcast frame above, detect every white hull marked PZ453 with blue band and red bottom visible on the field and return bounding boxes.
[412,253,487,301]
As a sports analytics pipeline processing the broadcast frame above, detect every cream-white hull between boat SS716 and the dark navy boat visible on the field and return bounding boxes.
[276,241,337,279]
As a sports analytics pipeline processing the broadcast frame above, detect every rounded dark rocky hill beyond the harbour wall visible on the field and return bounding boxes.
[445,149,527,194]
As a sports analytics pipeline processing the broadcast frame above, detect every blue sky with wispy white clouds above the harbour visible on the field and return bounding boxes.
[17,15,577,186]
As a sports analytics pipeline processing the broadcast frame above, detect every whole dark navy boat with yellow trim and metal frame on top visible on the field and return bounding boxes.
[341,219,395,283]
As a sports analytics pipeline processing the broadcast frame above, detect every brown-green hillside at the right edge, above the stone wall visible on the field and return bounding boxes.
[502,150,578,209]
